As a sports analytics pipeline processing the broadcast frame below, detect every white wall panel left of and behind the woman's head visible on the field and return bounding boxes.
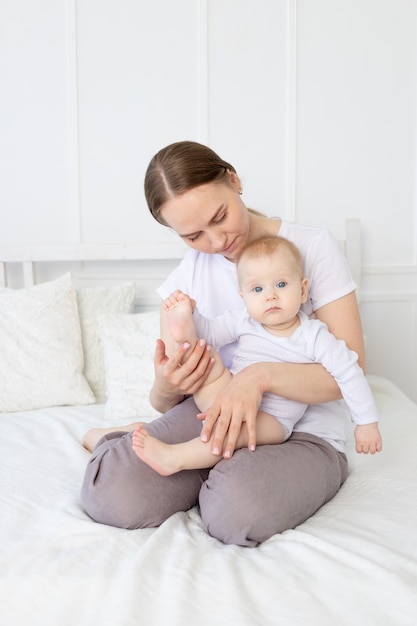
[77,0,200,245]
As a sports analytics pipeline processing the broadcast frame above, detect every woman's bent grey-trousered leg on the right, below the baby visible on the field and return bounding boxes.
[199,433,346,546]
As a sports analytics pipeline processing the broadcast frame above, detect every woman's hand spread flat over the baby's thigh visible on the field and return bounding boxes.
[198,363,263,458]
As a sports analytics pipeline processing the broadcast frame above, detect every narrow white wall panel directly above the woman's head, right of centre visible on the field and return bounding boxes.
[207,0,289,215]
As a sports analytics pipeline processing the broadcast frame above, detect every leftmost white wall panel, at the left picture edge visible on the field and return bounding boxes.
[0,0,71,243]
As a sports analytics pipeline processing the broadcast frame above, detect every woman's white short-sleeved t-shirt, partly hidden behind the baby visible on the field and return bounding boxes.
[158,221,355,451]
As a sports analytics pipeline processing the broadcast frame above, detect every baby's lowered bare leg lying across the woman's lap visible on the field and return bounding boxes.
[132,411,286,476]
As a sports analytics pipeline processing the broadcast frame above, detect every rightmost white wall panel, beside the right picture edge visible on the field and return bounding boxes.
[297,0,417,266]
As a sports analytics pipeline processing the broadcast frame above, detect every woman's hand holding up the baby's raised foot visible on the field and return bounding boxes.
[150,339,213,412]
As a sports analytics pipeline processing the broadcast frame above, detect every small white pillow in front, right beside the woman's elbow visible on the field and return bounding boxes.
[99,311,159,419]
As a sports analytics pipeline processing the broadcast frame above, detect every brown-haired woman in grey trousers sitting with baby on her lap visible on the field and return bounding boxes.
[82,142,364,546]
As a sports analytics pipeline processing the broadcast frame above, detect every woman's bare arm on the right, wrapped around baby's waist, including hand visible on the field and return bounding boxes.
[202,292,365,453]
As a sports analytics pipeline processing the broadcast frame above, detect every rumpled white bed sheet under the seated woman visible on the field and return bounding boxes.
[0,377,417,626]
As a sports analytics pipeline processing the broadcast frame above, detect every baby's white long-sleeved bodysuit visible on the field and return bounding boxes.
[193,308,378,438]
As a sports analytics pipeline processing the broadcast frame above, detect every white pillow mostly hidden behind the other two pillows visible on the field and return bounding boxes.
[77,282,136,403]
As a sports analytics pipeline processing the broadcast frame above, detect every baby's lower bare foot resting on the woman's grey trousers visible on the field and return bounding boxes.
[132,426,182,476]
